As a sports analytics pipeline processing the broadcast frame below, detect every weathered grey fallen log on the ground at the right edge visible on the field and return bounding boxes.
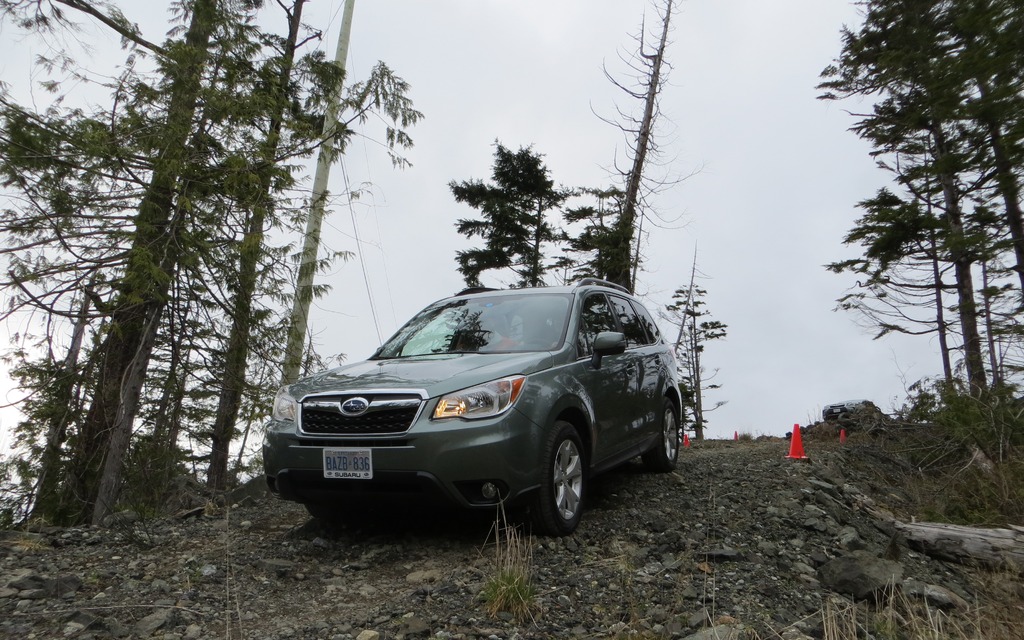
[893,520,1024,572]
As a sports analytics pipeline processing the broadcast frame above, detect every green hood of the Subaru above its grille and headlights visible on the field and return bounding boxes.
[289,352,552,398]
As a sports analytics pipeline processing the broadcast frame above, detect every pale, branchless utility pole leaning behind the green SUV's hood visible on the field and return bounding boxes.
[282,0,355,384]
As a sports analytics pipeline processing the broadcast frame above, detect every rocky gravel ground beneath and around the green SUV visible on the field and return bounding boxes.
[0,437,1024,640]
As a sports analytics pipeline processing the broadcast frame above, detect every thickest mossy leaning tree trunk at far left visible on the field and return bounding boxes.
[69,0,217,524]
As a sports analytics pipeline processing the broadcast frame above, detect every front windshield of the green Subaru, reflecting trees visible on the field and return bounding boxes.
[374,294,569,359]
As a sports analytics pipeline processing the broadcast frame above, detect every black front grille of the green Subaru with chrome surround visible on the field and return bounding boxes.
[299,393,423,435]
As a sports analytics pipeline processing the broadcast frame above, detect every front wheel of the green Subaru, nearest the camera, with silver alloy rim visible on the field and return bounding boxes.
[529,421,587,536]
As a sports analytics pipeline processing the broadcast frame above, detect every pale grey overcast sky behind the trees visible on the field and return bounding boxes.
[0,0,940,437]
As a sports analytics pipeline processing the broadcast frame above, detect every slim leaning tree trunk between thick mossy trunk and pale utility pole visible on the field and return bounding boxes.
[206,0,306,490]
